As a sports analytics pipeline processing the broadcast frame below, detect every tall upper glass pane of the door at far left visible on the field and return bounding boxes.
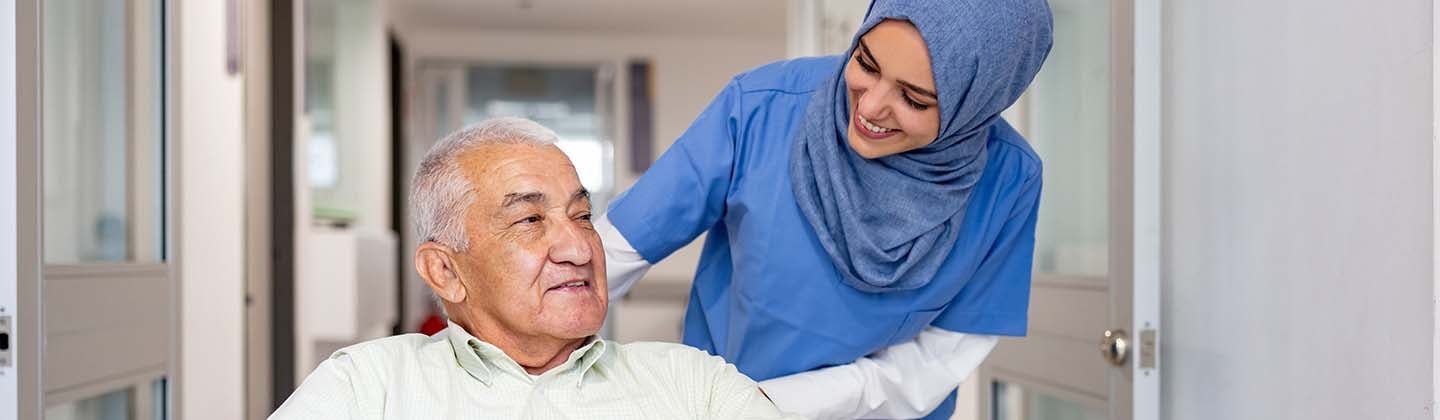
[40,0,164,263]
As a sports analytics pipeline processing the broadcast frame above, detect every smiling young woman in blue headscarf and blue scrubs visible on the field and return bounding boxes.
[598,0,1051,419]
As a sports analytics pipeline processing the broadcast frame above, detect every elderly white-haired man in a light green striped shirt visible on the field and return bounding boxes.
[271,118,785,419]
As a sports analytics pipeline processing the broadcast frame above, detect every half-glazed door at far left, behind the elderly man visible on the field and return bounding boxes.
[9,0,177,420]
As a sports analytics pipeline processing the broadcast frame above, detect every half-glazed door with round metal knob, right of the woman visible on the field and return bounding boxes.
[979,0,1159,420]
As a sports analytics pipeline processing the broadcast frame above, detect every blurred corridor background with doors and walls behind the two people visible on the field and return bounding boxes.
[0,0,1440,420]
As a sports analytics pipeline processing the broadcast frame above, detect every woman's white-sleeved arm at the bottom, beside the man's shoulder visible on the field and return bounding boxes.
[760,327,998,419]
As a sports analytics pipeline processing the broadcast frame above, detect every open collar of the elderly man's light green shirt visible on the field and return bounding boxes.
[445,321,609,385]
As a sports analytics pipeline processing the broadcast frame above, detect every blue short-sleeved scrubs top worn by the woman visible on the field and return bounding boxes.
[608,56,1041,419]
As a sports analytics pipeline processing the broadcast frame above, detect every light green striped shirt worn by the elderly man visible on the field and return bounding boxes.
[271,322,798,420]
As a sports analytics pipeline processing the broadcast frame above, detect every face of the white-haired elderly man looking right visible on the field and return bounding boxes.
[452,144,609,339]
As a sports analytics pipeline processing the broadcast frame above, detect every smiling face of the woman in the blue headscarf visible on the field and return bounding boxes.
[845,20,940,160]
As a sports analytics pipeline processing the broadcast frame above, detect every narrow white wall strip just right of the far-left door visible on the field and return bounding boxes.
[173,1,245,420]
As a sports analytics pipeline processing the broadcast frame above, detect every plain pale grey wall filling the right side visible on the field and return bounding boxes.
[1162,0,1434,420]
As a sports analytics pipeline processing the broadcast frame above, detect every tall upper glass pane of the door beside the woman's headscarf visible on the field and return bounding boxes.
[1017,0,1113,278]
